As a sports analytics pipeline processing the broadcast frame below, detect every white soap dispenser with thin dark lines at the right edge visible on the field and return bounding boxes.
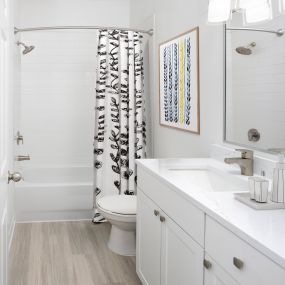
[271,153,285,203]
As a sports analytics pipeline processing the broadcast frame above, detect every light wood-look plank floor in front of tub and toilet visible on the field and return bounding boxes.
[9,221,141,285]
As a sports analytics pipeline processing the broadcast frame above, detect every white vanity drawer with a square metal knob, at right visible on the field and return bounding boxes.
[205,216,285,285]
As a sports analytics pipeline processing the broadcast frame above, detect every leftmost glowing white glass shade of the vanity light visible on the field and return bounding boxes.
[208,0,231,23]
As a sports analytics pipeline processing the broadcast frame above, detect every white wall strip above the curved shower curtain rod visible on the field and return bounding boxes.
[19,0,130,27]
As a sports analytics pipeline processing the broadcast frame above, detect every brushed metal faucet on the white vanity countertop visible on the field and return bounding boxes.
[224,149,253,176]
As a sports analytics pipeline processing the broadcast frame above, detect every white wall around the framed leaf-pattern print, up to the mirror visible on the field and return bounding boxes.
[131,0,223,157]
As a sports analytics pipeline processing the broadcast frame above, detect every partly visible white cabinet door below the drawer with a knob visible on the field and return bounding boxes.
[204,255,239,285]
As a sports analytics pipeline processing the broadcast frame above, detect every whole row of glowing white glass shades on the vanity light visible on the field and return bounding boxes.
[208,0,274,25]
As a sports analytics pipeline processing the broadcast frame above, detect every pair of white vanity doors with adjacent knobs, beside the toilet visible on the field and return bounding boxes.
[137,190,204,285]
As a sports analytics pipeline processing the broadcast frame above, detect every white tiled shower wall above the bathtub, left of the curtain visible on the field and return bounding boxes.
[21,31,97,164]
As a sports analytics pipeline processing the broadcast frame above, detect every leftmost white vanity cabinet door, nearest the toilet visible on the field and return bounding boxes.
[136,189,161,285]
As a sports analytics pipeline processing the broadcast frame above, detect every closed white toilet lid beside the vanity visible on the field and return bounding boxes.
[97,195,137,215]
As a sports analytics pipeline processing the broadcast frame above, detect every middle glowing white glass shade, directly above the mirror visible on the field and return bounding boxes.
[244,0,272,24]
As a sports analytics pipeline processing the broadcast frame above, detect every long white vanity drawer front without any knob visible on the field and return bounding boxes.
[138,167,205,244]
